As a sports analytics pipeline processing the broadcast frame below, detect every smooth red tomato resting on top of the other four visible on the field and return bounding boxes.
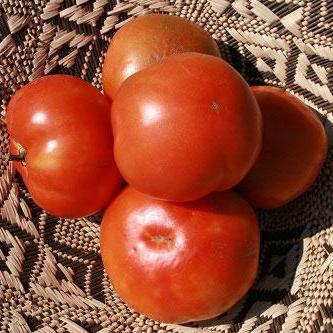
[111,53,262,201]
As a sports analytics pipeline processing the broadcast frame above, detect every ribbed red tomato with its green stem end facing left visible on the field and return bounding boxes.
[7,75,120,218]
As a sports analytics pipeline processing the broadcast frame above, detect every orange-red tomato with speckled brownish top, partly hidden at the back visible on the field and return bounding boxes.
[103,14,220,99]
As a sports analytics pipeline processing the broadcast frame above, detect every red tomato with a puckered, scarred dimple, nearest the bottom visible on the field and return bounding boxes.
[100,187,260,323]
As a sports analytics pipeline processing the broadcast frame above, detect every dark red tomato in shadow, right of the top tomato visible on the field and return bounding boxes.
[240,86,328,208]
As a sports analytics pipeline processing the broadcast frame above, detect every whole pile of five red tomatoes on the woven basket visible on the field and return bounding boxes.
[7,14,328,323]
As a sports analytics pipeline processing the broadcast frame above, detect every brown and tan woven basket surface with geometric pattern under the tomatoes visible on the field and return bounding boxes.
[0,0,333,333]
